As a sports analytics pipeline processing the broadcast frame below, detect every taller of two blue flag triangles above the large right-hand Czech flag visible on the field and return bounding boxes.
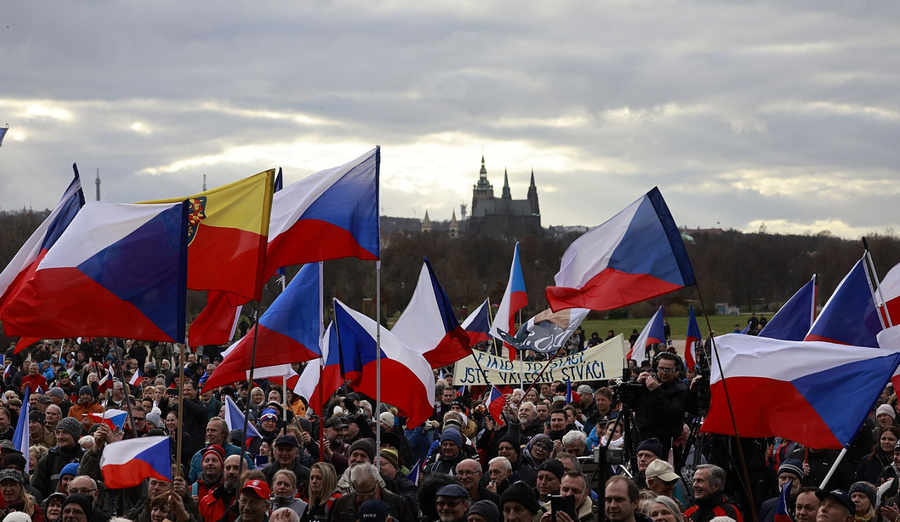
[805,258,882,348]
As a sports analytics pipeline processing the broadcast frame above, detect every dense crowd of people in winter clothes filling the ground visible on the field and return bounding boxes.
[0,339,900,522]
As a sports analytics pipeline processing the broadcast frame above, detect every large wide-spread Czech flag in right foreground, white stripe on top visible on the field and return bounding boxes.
[703,334,900,449]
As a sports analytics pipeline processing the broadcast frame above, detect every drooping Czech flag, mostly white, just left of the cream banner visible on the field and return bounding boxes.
[391,259,472,368]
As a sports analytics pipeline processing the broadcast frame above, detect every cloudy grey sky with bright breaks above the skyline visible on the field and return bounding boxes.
[0,0,900,238]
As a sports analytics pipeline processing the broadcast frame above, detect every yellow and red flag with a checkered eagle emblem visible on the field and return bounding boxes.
[145,169,275,305]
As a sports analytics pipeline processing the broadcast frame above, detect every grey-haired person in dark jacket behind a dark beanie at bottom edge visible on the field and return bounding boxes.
[330,463,415,522]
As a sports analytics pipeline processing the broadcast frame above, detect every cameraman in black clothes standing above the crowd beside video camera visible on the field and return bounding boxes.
[634,352,685,455]
